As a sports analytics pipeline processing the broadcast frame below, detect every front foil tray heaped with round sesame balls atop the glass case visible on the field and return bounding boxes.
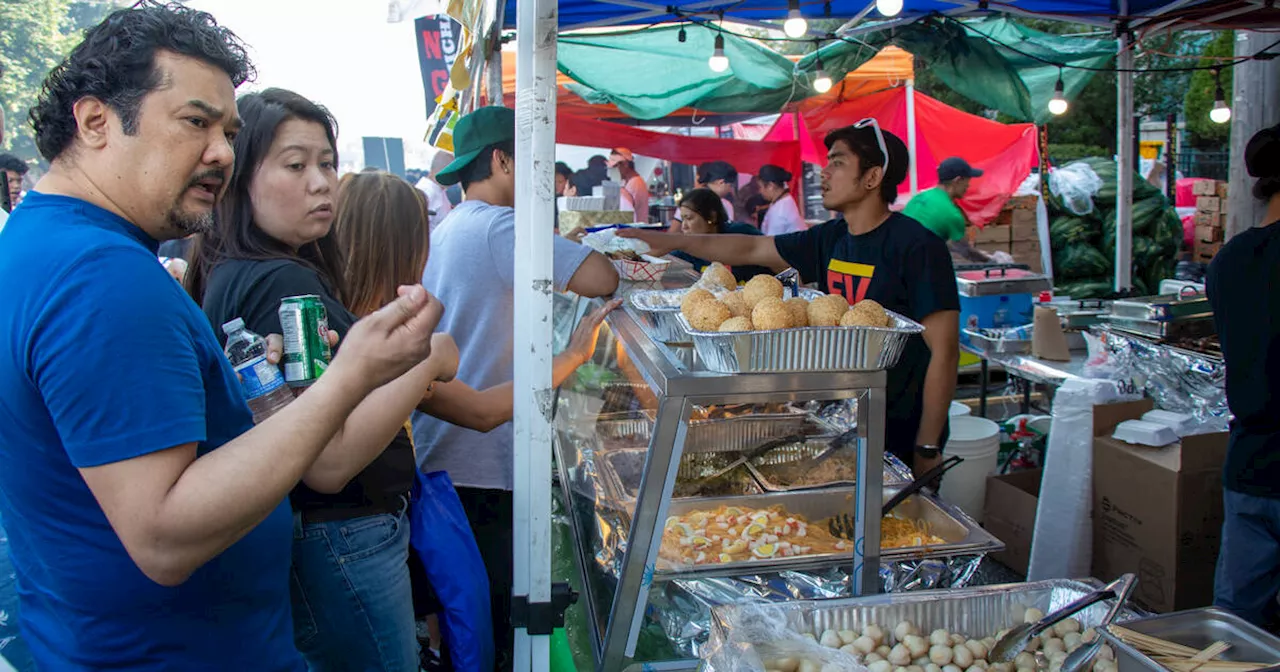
[676,311,924,374]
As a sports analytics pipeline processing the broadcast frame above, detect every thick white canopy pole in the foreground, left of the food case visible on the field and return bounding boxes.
[512,0,558,672]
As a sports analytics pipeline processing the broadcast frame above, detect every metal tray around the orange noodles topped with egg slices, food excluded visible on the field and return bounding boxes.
[618,486,1005,579]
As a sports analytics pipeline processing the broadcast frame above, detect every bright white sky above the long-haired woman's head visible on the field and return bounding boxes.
[186,0,445,169]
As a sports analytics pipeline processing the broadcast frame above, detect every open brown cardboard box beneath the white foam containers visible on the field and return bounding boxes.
[1093,401,1228,612]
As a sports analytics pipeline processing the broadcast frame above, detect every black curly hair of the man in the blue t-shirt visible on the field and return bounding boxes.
[31,1,255,161]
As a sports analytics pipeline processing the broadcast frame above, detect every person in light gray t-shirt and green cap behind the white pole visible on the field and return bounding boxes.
[413,108,618,669]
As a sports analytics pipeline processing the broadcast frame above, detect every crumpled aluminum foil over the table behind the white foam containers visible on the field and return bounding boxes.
[1093,329,1231,433]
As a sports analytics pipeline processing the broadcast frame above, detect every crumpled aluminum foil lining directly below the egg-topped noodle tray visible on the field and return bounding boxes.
[649,556,984,658]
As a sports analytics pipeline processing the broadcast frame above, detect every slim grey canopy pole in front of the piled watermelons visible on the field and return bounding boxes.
[1115,20,1137,292]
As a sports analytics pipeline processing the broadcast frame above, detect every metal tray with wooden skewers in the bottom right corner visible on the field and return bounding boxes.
[1102,607,1280,672]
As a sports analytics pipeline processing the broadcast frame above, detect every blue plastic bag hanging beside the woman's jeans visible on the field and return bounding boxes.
[410,471,494,672]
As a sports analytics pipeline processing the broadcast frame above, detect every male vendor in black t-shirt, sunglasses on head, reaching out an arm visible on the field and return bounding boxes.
[622,125,960,474]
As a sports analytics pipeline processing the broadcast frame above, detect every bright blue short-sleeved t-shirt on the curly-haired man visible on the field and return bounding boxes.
[0,192,305,671]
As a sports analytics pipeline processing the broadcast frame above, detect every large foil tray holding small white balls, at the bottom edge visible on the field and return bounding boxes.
[703,579,1137,672]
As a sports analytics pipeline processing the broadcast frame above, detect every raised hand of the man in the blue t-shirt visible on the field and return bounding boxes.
[329,284,444,389]
